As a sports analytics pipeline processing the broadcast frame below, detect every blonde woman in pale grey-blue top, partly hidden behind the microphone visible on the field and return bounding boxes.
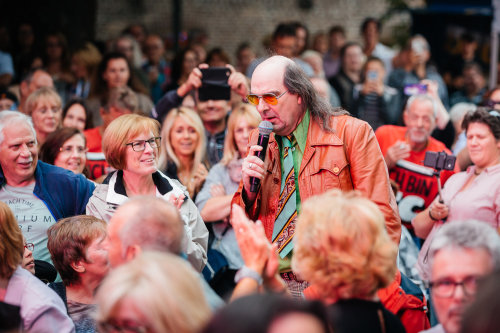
[196,103,261,294]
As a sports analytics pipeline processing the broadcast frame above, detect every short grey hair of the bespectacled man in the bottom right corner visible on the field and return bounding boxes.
[429,220,500,269]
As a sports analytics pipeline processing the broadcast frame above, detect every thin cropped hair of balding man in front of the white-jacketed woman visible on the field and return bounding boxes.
[118,196,184,255]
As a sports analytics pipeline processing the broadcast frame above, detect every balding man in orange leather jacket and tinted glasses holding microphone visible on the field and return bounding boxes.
[233,56,401,296]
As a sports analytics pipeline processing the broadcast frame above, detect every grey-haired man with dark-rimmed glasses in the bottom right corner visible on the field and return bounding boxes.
[424,220,500,333]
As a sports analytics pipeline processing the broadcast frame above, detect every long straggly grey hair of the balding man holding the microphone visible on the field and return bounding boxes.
[283,61,349,132]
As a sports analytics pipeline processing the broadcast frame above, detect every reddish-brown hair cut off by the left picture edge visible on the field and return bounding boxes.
[0,201,24,279]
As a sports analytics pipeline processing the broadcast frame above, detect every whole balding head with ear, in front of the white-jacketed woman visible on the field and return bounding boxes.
[108,196,184,267]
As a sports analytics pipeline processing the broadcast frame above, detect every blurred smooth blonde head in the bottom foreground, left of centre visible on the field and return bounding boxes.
[96,252,211,333]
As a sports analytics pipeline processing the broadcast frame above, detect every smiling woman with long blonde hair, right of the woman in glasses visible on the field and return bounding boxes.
[160,107,208,200]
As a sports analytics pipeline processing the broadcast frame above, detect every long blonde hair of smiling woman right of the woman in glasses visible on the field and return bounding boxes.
[159,107,206,177]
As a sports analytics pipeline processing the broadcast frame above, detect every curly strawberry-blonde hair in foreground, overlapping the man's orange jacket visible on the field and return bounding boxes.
[292,189,397,299]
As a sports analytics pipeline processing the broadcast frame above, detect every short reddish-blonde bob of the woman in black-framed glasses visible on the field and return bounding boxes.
[102,114,161,170]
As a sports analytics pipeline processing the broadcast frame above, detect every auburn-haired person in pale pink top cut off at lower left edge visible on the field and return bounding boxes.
[0,201,75,332]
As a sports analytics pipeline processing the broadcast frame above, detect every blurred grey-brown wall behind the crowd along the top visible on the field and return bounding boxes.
[95,0,404,57]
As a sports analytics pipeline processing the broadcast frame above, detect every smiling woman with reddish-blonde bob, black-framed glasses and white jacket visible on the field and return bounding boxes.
[87,114,208,271]
